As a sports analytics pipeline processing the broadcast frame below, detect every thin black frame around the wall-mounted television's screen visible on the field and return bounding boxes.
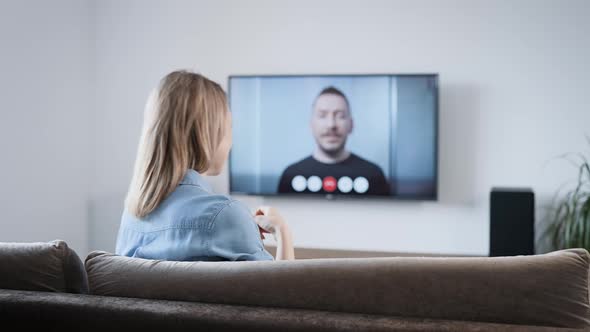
[227,73,440,202]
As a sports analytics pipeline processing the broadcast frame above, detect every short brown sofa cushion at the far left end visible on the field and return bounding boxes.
[0,240,88,293]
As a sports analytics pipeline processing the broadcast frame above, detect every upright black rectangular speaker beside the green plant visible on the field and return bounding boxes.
[490,187,535,256]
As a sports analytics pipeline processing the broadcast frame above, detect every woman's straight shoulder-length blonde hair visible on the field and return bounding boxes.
[125,70,228,218]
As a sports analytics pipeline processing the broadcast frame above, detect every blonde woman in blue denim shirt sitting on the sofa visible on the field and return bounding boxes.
[116,71,294,261]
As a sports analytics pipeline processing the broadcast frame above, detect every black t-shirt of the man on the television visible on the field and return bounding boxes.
[278,153,389,195]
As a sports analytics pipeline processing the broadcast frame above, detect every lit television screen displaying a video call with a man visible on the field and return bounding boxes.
[228,74,438,200]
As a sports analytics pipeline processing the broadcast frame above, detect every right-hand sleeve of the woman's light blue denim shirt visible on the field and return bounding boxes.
[208,201,274,261]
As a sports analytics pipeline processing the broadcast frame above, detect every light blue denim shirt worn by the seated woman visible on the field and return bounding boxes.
[115,170,273,261]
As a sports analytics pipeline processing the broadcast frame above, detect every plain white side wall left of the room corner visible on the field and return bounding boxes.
[0,0,93,254]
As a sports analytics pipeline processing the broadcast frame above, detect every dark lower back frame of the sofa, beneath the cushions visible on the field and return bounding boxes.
[0,289,587,332]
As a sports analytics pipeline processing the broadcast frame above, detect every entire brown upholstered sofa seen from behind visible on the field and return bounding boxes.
[0,241,590,331]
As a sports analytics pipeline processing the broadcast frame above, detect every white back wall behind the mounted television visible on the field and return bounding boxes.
[88,0,590,255]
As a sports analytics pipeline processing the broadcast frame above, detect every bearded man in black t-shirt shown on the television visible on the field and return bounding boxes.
[278,87,389,195]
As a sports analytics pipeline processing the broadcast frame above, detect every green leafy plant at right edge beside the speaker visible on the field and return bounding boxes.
[547,141,590,251]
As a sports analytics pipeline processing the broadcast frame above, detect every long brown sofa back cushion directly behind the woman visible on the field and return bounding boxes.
[86,249,590,328]
